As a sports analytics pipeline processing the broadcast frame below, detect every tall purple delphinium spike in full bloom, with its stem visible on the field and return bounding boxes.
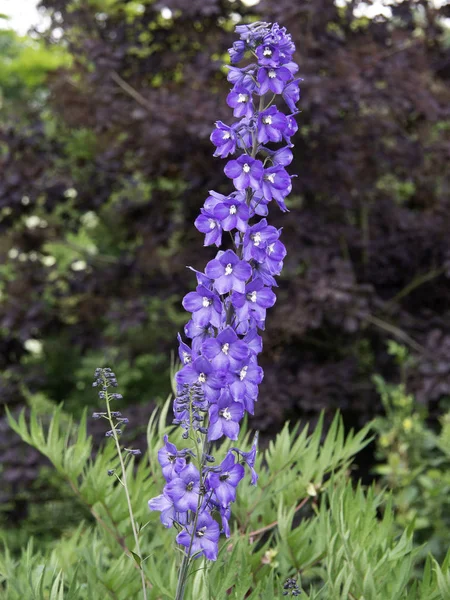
[149,22,300,600]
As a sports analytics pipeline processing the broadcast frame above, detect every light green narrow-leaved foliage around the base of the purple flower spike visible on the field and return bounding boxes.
[0,402,450,600]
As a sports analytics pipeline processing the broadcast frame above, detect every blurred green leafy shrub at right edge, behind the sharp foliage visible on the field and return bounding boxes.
[374,343,450,558]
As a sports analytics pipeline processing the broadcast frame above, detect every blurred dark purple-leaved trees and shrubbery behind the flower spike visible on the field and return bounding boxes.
[0,0,450,548]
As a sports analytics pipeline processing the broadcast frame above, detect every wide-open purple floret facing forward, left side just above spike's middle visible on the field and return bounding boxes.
[205,250,252,295]
